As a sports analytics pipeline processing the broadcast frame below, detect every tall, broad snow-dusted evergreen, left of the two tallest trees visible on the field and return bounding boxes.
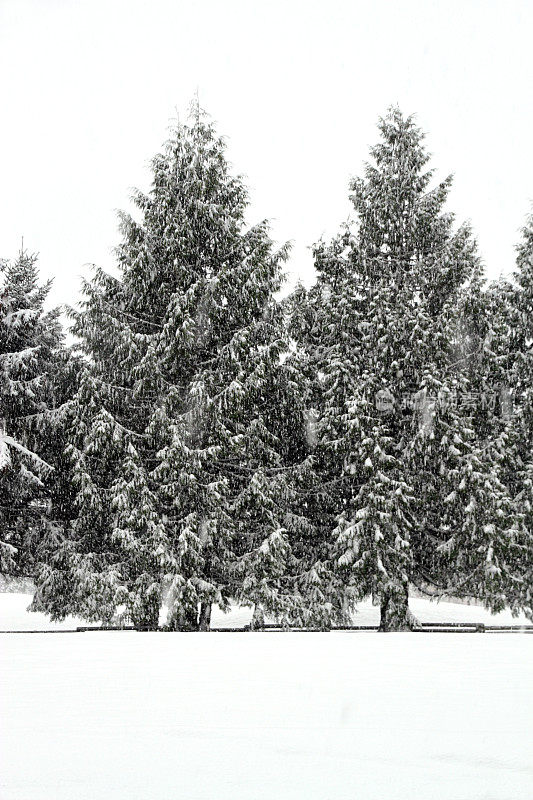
[34,109,312,629]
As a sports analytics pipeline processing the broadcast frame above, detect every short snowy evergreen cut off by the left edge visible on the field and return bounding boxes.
[0,250,68,576]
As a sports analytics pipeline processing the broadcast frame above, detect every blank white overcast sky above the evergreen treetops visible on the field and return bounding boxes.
[0,0,533,302]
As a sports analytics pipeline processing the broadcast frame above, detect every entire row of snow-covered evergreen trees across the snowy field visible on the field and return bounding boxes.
[0,99,533,630]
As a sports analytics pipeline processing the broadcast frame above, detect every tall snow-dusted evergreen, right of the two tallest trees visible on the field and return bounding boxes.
[290,109,498,630]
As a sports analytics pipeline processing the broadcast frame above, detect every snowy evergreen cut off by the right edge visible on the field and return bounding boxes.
[428,209,533,615]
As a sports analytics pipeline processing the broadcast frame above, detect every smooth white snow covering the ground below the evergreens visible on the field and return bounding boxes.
[0,594,533,800]
